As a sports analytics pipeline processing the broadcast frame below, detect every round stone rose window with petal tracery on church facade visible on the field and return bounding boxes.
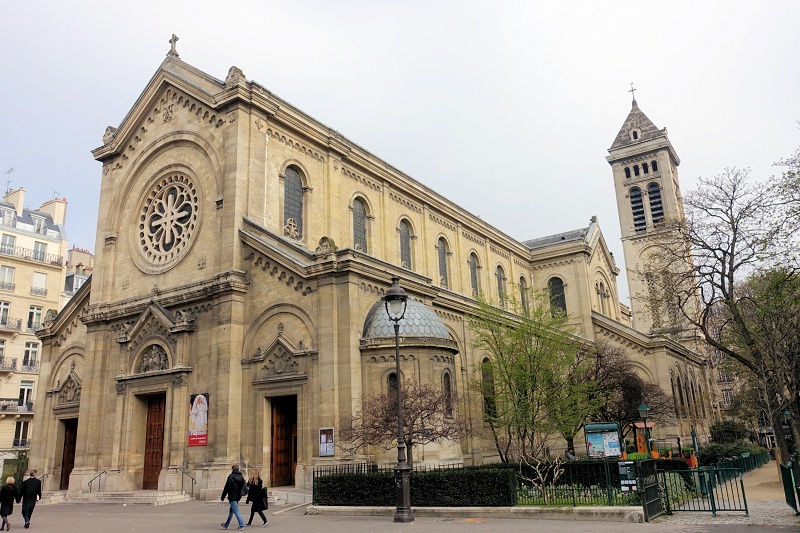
[139,174,199,266]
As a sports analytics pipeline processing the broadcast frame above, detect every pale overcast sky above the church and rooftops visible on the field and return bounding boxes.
[0,0,800,300]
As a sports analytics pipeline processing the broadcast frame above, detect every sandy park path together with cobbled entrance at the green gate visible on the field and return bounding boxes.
[656,461,800,528]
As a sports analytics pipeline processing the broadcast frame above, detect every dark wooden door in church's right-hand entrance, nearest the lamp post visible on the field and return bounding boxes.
[270,396,297,487]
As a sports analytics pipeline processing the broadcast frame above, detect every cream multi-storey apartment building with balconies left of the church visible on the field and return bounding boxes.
[0,188,67,458]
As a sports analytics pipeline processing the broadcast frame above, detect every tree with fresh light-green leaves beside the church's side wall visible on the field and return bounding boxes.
[468,291,598,462]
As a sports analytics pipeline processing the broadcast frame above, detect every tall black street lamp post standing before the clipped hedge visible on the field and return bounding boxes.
[383,276,414,523]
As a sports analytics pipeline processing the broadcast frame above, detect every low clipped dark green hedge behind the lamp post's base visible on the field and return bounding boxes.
[314,466,518,507]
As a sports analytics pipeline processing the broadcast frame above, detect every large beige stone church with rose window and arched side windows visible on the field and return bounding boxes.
[31,42,712,499]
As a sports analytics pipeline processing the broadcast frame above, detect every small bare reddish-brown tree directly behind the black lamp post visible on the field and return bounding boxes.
[339,381,471,464]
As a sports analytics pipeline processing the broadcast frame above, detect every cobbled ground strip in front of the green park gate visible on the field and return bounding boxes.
[654,500,800,526]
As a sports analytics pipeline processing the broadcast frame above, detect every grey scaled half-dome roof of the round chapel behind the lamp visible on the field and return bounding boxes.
[361,298,452,341]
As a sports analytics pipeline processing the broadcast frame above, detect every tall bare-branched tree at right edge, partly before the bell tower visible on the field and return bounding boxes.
[644,169,800,460]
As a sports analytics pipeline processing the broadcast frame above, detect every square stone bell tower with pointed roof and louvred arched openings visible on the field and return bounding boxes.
[606,91,683,333]
